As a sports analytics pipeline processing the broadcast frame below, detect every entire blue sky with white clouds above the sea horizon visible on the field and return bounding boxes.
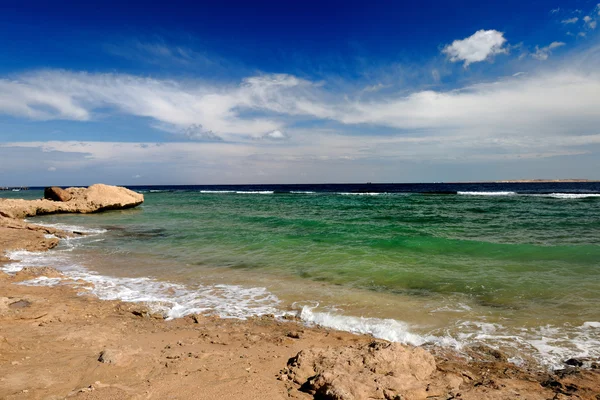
[0,0,600,186]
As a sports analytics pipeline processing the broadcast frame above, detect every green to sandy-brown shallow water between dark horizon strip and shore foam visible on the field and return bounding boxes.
[8,192,600,368]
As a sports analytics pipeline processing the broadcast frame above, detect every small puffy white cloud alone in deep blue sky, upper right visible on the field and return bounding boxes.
[442,29,508,67]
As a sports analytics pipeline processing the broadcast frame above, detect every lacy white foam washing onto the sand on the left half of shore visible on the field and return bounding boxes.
[2,241,284,319]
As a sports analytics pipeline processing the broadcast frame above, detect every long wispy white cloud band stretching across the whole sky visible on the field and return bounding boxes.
[0,63,600,141]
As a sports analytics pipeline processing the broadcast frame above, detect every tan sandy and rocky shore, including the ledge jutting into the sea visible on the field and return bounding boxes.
[0,187,600,400]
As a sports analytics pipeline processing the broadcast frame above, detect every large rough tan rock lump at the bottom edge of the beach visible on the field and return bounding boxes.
[288,341,436,400]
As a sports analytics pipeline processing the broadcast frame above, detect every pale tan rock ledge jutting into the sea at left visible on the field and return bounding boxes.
[0,184,144,219]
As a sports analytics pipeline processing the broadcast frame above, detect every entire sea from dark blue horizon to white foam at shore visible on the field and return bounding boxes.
[0,182,600,369]
